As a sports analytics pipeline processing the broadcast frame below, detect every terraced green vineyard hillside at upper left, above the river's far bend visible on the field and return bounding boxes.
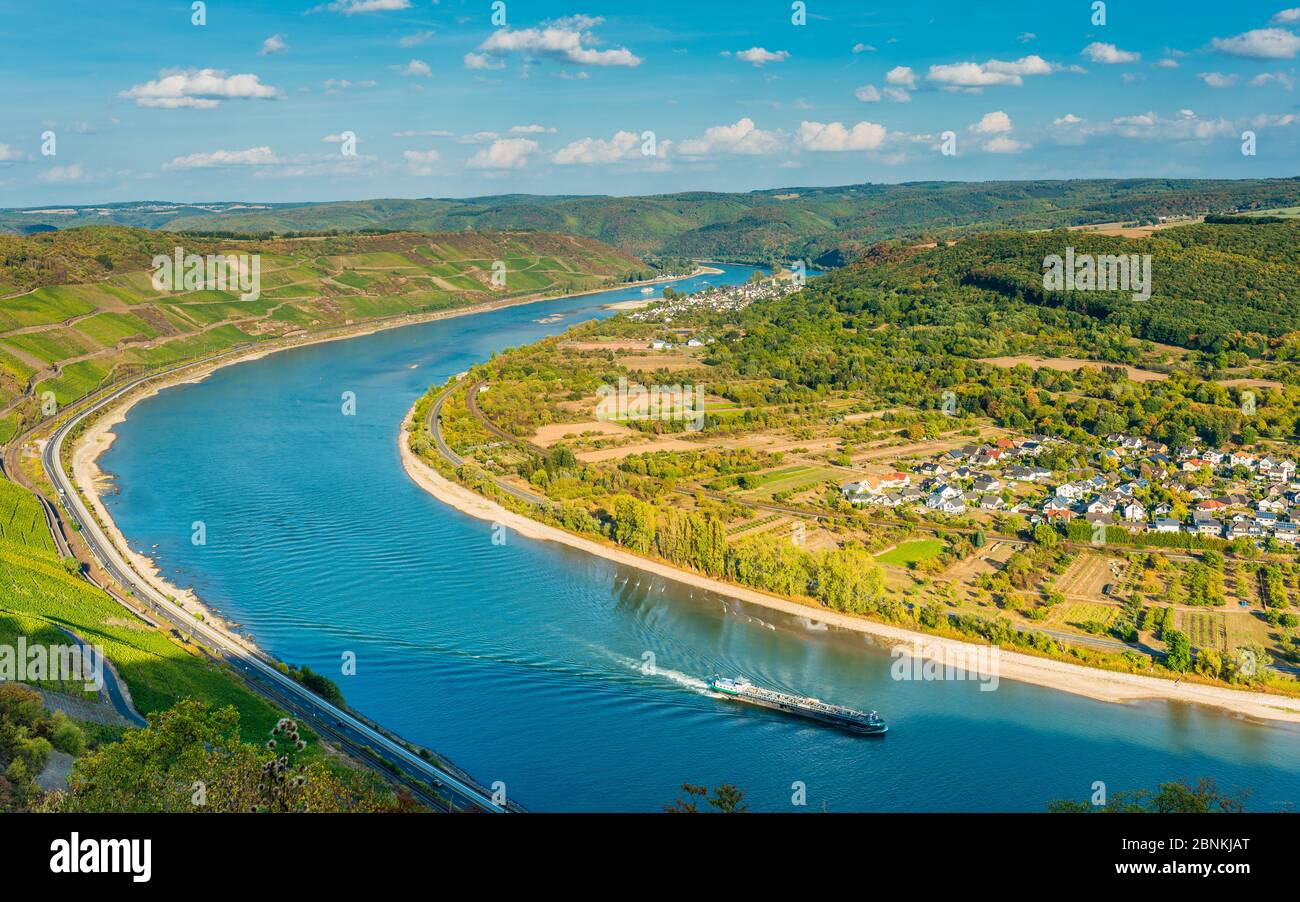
[0,226,653,443]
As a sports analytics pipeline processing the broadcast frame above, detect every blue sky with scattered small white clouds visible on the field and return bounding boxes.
[0,0,1300,207]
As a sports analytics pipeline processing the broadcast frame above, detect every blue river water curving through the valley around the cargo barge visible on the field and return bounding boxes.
[101,265,1300,811]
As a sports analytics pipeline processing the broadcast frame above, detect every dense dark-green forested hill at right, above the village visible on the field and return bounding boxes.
[800,220,1300,357]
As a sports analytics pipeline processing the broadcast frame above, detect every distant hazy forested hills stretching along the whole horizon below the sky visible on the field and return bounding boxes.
[0,178,1300,265]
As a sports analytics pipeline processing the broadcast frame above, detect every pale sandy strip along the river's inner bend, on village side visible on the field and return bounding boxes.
[398,413,1300,723]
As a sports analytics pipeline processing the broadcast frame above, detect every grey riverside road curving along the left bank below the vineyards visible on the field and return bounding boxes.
[42,364,509,814]
